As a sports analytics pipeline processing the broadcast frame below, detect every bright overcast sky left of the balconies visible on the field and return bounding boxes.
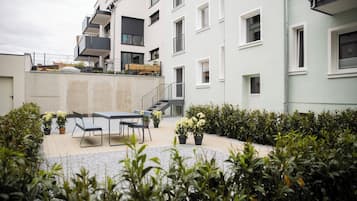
[0,0,96,55]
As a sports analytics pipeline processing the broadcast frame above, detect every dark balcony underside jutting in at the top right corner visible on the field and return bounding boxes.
[309,0,357,15]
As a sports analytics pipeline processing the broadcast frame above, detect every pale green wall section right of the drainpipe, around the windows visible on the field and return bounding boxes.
[288,0,357,112]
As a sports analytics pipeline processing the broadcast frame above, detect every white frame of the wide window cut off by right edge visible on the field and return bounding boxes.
[327,22,357,78]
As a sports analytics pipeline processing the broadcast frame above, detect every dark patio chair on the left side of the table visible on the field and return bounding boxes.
[72,112,103,147]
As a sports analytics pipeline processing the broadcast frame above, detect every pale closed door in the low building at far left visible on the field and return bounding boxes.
[0,77,14,116]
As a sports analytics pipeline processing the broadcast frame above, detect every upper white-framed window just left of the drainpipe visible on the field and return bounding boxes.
[240,9,261,45]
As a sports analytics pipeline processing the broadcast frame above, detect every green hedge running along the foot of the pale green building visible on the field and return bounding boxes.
[186,104,357,145]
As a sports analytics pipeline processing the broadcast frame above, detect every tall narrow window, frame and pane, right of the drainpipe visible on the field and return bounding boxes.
[289,24,306,72]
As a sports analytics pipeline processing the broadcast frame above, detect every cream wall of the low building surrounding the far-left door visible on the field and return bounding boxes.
[0,54,31,108]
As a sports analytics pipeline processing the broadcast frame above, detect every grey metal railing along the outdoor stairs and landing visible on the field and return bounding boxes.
[141,82,185,110]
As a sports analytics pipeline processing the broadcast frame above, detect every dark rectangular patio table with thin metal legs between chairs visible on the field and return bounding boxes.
[93,112,145,146]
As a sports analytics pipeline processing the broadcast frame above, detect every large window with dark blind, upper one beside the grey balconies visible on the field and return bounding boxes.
[121,17,144,46]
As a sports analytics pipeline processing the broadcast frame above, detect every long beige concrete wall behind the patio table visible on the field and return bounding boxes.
[26,72,163,113]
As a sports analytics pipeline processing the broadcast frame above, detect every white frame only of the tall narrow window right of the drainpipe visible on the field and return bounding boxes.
[289,22,308,75]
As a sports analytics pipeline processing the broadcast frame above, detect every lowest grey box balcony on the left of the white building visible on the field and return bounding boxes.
[78,36,110,57]
